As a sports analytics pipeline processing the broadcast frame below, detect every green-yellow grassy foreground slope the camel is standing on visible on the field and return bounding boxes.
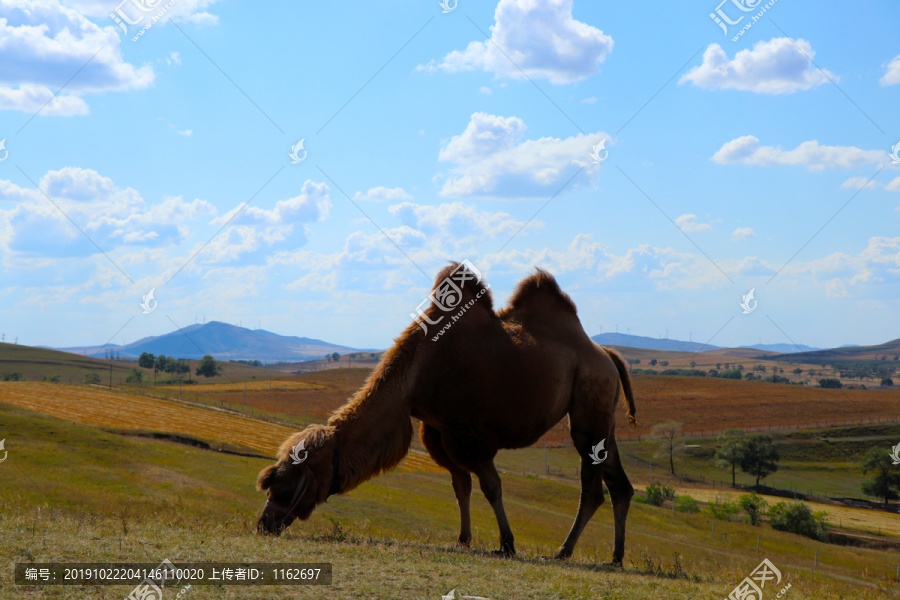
[0,405,900,600]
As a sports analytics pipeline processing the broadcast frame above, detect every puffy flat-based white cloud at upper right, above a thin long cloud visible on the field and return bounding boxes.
[679,38,837,94]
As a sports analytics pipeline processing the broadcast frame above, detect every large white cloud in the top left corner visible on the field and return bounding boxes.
[0,0,154,116]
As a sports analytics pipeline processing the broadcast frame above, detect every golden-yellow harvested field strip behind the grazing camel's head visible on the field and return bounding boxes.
[0,382,441,472]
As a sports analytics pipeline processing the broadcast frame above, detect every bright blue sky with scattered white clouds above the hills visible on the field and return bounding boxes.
[0,0,900,348]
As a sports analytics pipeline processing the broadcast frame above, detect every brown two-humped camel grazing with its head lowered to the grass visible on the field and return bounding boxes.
[257,263,635,564]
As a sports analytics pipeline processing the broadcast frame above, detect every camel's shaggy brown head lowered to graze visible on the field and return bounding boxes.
[256,425,337,535]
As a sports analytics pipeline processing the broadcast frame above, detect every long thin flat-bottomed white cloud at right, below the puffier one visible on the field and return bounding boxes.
[712,135,888,171]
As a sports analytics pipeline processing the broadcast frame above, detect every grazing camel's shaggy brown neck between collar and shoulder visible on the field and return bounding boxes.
[328,377,412,492]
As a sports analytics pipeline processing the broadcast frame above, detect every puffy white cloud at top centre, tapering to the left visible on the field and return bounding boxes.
[418,0,613,84]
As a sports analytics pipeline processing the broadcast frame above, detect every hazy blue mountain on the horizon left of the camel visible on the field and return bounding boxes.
[59,321,359,362]
